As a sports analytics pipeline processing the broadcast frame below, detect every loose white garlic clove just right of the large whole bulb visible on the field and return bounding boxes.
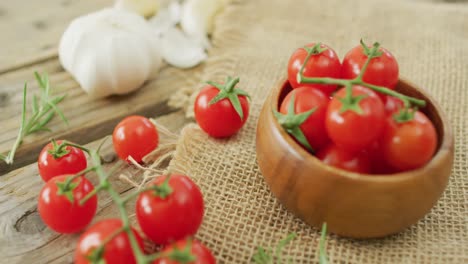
[161,27,207,68]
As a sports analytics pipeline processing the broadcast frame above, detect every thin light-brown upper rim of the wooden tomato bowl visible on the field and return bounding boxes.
[267,78,453,183]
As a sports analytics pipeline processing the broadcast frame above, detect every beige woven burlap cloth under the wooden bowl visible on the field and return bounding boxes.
[163,0,468,263]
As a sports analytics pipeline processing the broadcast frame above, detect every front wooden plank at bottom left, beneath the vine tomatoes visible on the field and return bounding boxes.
[0,111,188,264]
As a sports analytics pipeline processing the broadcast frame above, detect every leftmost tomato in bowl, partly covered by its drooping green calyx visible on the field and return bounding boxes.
[280,87,330,151]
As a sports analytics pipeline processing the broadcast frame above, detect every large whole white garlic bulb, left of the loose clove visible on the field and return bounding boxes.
[59,9,161,97]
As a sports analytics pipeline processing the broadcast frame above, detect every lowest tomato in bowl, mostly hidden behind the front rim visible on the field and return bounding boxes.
[317,144,371,173]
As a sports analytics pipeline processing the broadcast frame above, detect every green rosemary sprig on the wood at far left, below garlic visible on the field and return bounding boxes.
[0,72,68,164]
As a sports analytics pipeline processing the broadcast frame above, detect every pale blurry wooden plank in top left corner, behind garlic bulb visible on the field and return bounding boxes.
[0,0,114,73]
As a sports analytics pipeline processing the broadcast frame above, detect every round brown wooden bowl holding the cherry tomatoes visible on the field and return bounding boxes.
[257,80,453,238]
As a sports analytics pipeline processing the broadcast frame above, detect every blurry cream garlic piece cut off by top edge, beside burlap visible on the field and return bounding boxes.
[180,0,225,38]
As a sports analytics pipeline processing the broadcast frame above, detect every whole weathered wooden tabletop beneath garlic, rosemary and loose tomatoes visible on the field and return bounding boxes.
[0,0,199,264]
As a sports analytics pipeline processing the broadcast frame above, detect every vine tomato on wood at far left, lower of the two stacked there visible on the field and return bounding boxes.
[38,175,97,234]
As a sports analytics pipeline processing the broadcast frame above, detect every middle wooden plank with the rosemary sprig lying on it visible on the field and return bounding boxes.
[0,59,202,175]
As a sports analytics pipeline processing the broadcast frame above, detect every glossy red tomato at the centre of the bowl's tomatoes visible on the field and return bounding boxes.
[325,85,385,152]
